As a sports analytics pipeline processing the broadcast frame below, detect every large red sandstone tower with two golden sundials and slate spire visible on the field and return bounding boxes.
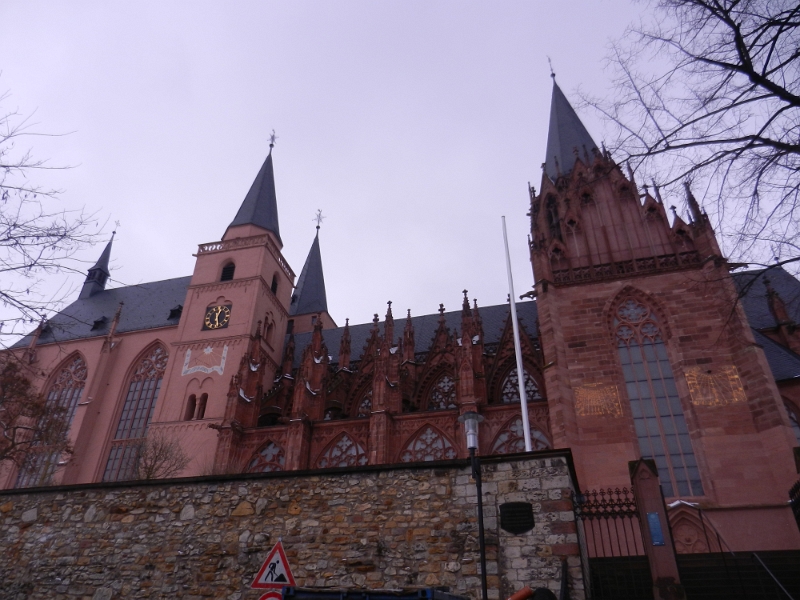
[530,81,794,518]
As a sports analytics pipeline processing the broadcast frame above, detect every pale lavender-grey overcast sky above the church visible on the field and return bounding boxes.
[0,0,641,332]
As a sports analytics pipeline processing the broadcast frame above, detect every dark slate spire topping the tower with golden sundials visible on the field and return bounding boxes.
[545,78,597,181]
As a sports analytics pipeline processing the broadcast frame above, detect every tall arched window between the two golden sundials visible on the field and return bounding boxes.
[614,298,703,496]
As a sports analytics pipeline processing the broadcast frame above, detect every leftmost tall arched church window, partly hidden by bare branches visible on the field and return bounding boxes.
[15,356,86,487]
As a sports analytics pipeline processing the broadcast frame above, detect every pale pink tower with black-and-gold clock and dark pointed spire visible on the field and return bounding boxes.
[151,143,295,472]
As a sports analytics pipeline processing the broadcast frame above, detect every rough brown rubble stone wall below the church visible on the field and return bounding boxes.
[0,451,583,600]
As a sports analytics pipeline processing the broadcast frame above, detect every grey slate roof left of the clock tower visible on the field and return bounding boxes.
[15,277,192,347]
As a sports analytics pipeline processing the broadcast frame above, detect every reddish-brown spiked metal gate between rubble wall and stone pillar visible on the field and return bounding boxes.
[574,488,653,600]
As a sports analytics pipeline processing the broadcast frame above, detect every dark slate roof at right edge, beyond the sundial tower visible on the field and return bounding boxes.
[732,267,800,329]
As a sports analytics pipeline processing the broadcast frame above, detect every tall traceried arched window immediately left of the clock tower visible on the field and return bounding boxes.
[103,345,169,481]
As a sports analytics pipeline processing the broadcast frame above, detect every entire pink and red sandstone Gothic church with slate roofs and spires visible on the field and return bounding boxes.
[0,86,800,552]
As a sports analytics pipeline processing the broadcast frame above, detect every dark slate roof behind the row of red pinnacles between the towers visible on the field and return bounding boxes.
[284,301,539,368]
